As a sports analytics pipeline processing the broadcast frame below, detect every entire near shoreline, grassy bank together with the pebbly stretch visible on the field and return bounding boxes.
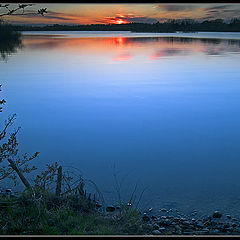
[0,188,240,236]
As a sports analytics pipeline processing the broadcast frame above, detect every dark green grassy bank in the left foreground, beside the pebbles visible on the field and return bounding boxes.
[0,189,148,235]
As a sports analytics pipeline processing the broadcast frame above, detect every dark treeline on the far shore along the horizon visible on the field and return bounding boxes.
[14,18,240,32]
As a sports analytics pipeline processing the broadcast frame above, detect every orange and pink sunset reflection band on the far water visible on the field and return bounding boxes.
[23,33,240,61]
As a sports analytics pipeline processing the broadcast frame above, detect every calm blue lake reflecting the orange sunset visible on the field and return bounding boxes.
[0,32,240,216]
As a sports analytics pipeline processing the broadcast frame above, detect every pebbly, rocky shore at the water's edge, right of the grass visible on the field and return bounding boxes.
[138,208,240,235]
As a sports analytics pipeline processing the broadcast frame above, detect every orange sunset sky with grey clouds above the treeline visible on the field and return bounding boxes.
[0,3,240,24]
